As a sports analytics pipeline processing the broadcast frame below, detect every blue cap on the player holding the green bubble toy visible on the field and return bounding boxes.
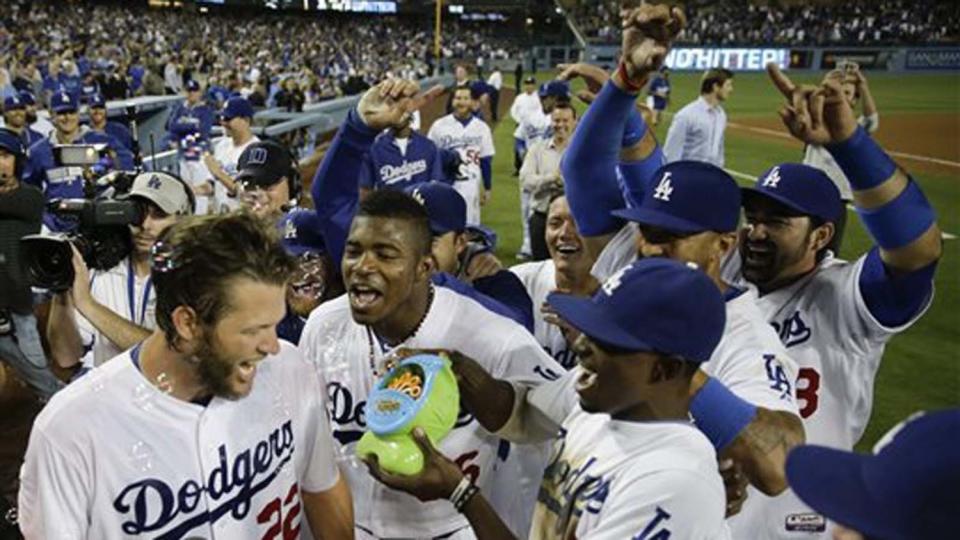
[547,257,727,362]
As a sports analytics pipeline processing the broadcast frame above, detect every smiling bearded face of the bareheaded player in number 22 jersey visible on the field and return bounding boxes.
[193,277,286,399]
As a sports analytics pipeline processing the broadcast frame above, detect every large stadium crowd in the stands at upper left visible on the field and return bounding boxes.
[0,0,515,106]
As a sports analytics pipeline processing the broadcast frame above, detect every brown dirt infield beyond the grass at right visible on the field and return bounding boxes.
[730,113,960,176]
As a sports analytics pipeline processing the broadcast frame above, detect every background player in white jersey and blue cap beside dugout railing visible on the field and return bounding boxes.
[195,97,260,213]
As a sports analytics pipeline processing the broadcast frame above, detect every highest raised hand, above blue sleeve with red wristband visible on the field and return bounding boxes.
[620,4,687,86]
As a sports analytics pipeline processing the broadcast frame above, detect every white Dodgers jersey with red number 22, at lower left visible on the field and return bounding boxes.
[19,342,339,540]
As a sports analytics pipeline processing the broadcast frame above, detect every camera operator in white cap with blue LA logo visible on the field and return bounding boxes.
[47,172,195,368]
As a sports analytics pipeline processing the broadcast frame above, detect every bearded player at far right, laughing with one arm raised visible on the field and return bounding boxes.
[725,67,942,539]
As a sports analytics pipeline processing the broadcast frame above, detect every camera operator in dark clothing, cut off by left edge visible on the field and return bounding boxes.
[0,128,63,401]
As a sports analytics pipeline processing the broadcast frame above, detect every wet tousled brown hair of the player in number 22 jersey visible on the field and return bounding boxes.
[151,211,296,350]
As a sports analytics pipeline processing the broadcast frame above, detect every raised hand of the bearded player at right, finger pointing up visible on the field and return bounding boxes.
[767,63,857,146]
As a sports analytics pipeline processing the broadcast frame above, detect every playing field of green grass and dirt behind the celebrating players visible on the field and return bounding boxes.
[483,73,960,449]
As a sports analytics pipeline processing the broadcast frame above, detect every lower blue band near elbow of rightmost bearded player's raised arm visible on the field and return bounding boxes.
[857,180,936,249]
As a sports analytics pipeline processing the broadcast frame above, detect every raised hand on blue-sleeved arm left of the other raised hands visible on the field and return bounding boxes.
[357,79,443,130]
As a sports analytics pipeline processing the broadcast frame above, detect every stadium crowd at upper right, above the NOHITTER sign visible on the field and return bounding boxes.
[574,0,960,46]
